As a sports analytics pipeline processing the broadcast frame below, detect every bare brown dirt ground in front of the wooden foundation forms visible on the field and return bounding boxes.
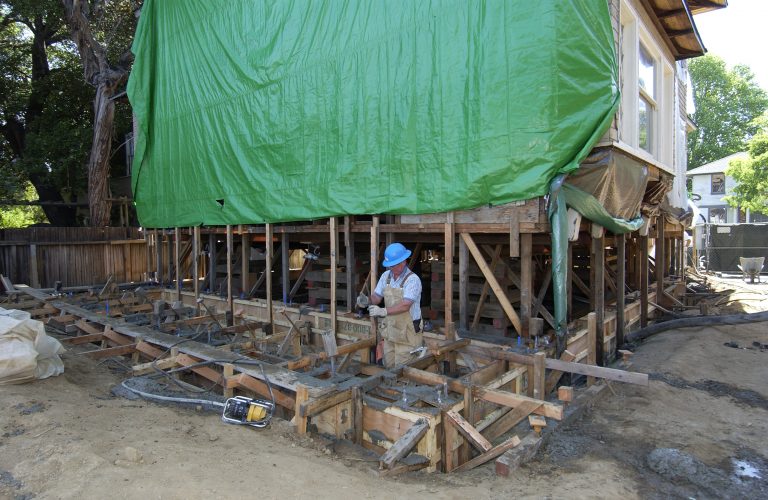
[0,280,768,499]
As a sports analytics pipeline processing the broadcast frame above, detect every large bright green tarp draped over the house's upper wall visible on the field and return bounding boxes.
[128,0,618,227]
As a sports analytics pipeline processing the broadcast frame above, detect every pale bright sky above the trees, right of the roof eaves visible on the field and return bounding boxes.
[693,0,768,91]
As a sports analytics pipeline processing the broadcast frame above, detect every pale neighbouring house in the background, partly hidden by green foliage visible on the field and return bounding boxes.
[686,151,768,224]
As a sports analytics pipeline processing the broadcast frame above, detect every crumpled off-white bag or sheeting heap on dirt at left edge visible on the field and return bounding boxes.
[0,308,64,385]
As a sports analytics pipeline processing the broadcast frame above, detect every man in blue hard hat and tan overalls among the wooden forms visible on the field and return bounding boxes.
[368,243,424,368]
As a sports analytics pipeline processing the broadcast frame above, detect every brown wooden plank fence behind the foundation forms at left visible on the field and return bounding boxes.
[0,227,147,288]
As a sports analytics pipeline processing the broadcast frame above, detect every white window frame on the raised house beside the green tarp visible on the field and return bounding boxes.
[619,0,675,171]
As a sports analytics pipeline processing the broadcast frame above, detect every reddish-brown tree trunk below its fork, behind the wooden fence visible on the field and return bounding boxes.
[88,82,116,226]
